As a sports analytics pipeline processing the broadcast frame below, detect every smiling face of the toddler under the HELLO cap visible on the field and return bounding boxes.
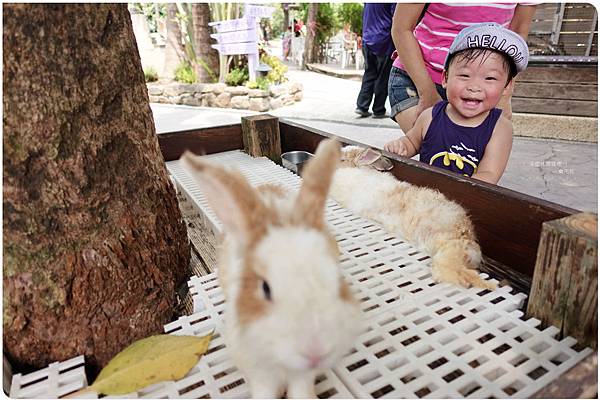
[442,52,513,118]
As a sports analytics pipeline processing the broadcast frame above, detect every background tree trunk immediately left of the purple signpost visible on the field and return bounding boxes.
[192,3,219,82]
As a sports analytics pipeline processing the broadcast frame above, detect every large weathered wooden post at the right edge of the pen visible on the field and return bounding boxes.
[527,213,598,349]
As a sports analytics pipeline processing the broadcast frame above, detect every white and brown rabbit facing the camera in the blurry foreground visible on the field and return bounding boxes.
[181,141,362,398]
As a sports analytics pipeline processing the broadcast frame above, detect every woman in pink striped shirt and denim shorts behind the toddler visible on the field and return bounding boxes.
[388,3,535,132]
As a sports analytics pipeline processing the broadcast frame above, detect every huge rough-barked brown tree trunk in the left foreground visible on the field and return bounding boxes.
[3,4,190,372]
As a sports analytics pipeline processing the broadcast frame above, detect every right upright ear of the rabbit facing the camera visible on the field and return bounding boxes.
[293,139,341,230]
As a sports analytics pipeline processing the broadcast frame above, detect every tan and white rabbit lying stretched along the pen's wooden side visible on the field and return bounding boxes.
[329,146,496,289]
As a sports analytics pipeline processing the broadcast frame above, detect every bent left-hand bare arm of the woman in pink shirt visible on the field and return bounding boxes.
[392,3,441,119]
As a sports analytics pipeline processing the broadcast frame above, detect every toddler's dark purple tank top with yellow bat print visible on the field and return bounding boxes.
[419,100,502,177]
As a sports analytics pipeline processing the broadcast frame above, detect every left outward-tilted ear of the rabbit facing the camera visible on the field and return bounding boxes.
[180,151,265,245]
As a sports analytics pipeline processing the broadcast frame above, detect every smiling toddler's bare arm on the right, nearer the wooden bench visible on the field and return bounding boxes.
[473,116,512,184]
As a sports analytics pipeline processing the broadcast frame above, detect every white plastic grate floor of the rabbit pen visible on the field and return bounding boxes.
[10,151,592,398]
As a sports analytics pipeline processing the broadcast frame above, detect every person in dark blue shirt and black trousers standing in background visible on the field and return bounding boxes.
[355,3,396,118]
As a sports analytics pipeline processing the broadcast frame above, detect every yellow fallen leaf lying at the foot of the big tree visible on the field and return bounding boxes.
[86,333,212,395]
